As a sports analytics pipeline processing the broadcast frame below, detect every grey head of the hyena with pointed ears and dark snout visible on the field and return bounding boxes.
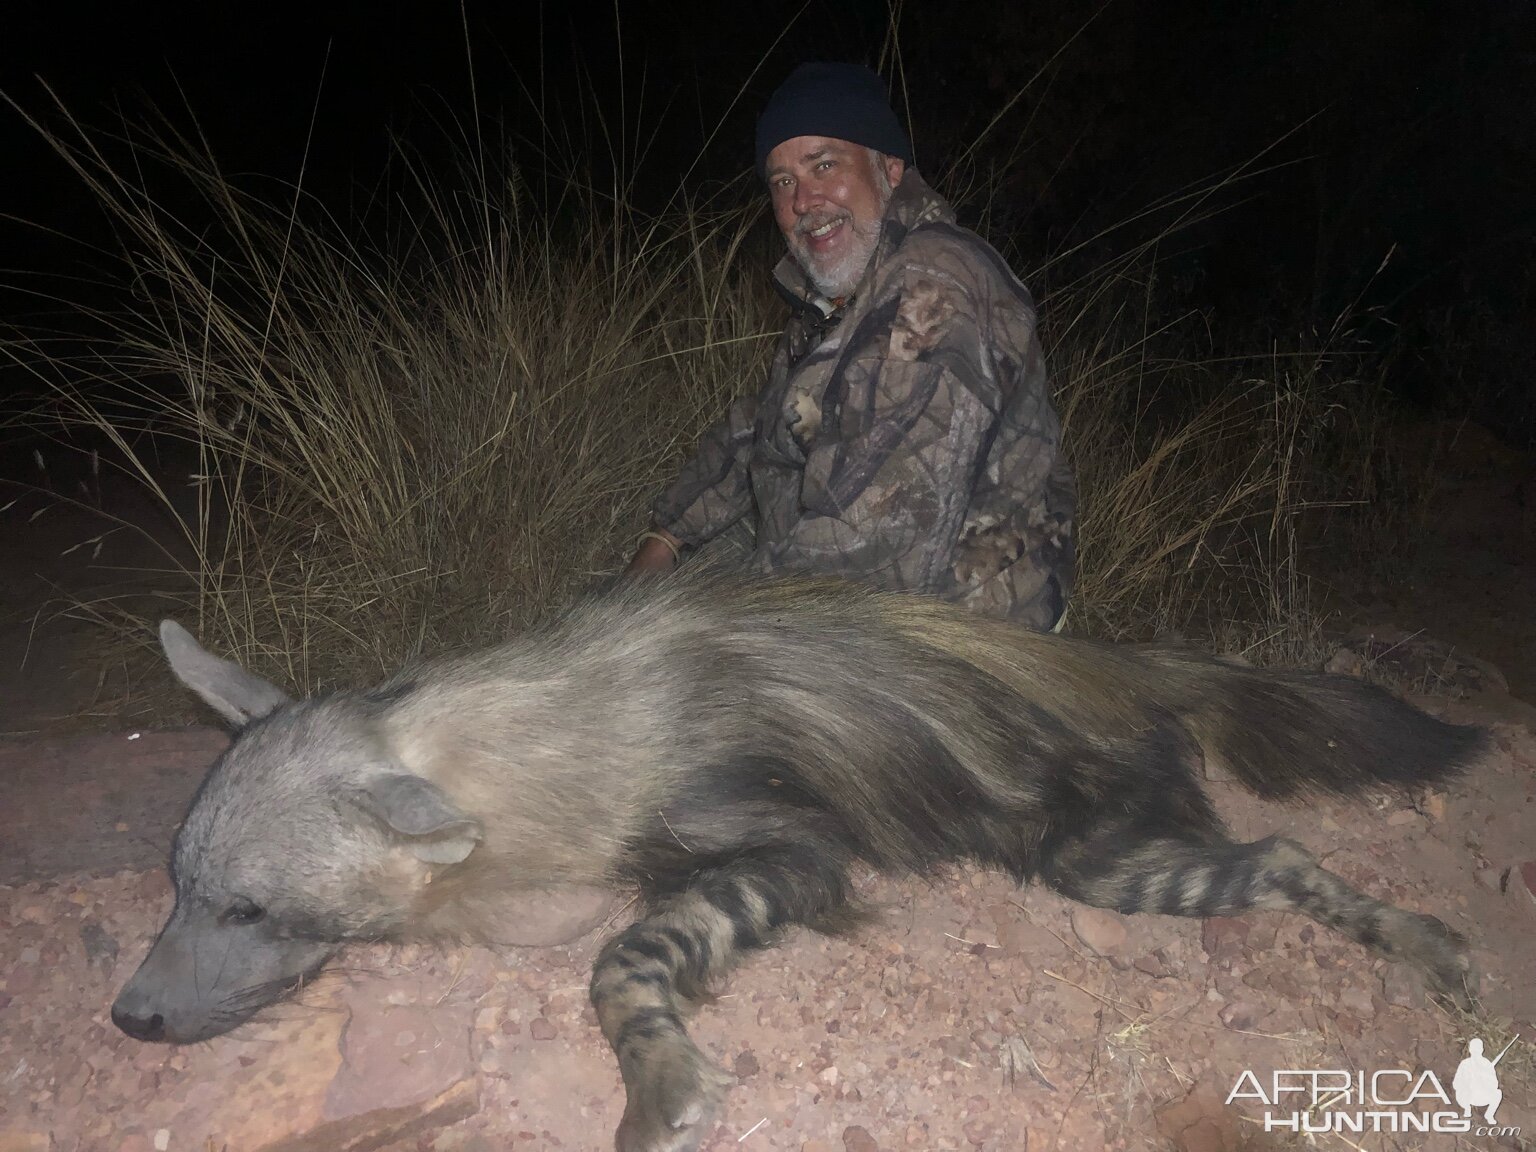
[112,621,481,1043]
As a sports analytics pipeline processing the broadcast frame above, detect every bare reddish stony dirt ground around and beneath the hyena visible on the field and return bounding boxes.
[0,427,1536,1152]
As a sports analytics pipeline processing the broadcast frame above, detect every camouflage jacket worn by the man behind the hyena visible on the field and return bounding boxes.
[653,169,1075,630]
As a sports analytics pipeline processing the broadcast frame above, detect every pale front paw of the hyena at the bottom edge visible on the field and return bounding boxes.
[616,1040,730,1152]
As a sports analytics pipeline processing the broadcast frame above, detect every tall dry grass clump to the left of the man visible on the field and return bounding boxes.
[8,103,773,688]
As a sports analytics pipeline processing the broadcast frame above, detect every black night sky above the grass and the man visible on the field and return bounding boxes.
[0,0,1536,423]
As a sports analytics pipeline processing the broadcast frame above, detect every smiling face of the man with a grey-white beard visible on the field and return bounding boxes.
[766,137,906,298]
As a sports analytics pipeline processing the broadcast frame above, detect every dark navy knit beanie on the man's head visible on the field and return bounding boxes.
[757,63,912,177]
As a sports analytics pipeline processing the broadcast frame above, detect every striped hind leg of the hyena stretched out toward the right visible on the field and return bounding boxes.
[1044,828,1475,1008]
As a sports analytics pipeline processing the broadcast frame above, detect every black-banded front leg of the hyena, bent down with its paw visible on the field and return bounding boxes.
[591,846,848,1152]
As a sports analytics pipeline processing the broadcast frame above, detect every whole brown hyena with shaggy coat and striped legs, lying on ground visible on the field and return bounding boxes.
[114,573,1484,1152]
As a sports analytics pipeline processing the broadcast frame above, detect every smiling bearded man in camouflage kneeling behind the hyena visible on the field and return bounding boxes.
[630,65,1075,630]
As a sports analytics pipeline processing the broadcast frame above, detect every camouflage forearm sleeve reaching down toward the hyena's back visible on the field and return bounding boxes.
[651,396,757,547]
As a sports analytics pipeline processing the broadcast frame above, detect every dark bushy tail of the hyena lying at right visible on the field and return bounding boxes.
[1154,653,1488,799]
